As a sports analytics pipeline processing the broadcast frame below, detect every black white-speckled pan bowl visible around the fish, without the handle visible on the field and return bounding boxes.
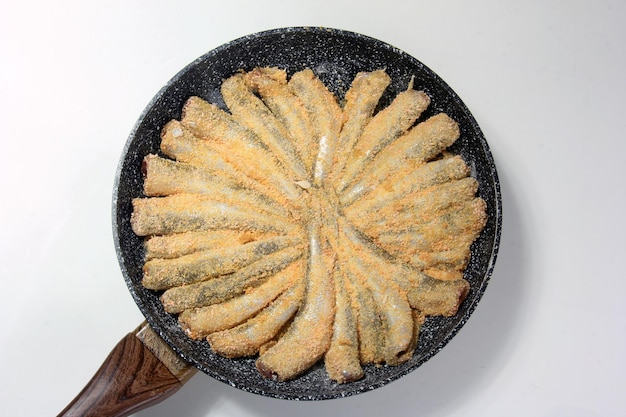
[113,28,501,400]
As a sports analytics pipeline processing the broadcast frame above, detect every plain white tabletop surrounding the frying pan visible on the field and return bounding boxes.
[0,0,626,417]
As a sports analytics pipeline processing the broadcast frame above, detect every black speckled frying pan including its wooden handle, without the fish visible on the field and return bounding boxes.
[62,27,502,415]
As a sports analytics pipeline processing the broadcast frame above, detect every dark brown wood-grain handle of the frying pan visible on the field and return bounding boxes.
[59,323,195,417]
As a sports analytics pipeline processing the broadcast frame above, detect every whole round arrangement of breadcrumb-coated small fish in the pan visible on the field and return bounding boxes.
[131,68,486,383]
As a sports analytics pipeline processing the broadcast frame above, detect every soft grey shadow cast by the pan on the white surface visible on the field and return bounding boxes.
[136,159,530,417]
